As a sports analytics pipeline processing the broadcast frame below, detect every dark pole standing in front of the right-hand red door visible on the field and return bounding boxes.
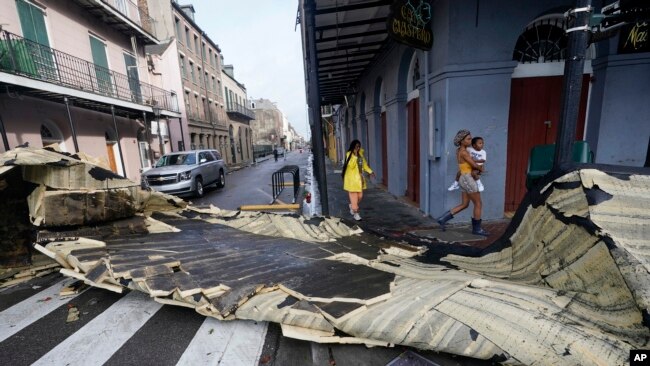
[553,0,593,169]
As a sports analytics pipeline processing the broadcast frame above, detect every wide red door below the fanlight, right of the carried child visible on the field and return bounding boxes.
[504,75,589,212]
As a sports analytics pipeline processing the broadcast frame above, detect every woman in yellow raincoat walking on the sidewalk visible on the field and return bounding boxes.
[341,140,375,221]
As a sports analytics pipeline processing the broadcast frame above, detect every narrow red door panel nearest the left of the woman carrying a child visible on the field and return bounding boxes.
[406,98,420,204]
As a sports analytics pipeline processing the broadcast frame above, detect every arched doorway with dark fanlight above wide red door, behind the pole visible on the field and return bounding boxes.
[504,14,593,212]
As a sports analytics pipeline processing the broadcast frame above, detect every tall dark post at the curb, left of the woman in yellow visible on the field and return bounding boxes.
[301,0,329,216]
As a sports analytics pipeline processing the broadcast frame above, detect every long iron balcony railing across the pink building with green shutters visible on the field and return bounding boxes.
[0,31,178,112]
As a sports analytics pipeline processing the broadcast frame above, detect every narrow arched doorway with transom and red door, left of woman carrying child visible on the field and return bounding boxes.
[406,54,420,205]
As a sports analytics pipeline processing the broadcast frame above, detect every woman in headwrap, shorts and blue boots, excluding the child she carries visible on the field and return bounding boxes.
[437,130,490,236]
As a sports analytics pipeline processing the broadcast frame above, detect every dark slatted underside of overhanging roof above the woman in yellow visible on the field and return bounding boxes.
[315,0,392,104]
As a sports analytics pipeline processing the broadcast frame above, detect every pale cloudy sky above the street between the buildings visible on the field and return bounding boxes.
[190,0,309,138]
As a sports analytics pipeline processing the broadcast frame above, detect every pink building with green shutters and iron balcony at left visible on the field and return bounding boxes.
[0,0,184,181]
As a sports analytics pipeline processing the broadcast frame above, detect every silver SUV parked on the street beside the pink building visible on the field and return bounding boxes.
[142,150,226,197]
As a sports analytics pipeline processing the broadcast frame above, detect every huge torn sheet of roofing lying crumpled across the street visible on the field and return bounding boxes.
[0,148,650,364]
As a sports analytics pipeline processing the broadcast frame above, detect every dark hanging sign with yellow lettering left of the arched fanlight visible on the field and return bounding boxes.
[386,0,433,50]
